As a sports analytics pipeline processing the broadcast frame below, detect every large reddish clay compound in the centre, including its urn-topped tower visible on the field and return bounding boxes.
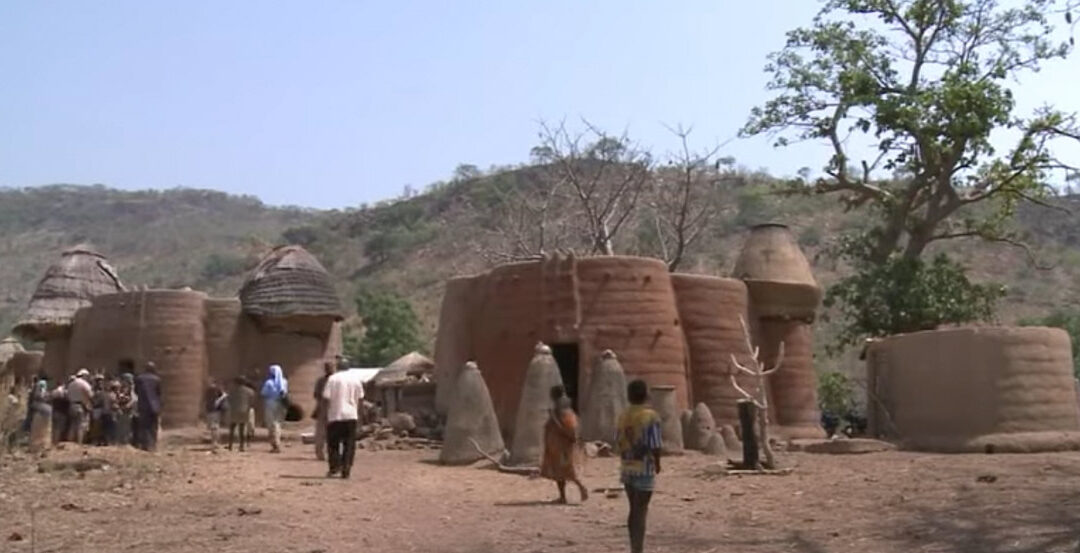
[435,225,822,437]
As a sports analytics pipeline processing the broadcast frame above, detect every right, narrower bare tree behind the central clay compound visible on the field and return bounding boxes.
[648,125,732,271]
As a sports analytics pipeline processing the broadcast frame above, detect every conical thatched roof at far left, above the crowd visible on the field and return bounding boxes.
[14,245,124,340]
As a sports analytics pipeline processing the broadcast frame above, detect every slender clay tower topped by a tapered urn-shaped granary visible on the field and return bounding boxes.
[734,224,824,439]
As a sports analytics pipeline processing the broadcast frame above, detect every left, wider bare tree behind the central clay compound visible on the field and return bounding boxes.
[532,121,652,255]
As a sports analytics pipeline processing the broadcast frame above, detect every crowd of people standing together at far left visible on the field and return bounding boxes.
[23,361,162,450]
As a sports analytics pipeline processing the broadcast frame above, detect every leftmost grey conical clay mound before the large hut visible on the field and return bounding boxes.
[438,362,505,464]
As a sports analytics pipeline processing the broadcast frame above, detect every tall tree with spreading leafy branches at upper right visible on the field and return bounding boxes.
[742,0,1080,265]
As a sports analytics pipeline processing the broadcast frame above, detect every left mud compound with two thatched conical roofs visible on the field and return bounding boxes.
[9,246,342,427]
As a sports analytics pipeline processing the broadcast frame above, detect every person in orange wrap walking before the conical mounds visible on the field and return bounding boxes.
[540,386,589,504]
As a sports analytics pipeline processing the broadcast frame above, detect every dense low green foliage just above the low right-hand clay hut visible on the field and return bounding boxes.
[825,246,1004,353]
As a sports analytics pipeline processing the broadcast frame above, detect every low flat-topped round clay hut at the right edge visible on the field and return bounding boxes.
[867,327,1080,453]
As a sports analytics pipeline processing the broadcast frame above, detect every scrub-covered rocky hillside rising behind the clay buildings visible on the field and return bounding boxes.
[0,176,1080,365]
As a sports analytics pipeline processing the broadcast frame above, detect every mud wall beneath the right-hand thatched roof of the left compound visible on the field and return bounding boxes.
[244,323,341,417]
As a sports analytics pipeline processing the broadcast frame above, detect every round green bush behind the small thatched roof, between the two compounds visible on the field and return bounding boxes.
[346,289,423,367]
